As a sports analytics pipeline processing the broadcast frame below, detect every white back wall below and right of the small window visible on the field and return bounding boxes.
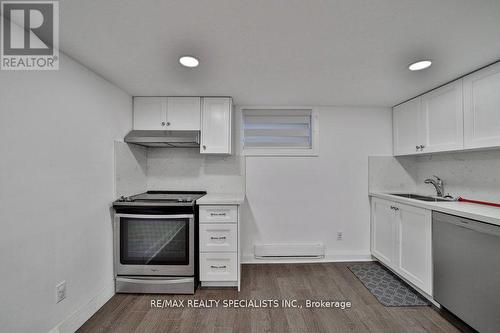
[241,107,392,261]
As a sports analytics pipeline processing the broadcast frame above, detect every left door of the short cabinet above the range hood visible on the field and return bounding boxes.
[134,97,167,130]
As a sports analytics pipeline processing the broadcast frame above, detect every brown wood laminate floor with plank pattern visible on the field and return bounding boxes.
[78,263,459,333]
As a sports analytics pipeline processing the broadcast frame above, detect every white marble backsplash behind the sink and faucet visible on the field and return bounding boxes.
[369,150,500,202]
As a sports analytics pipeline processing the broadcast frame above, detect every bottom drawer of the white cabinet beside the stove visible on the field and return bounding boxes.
[200,253,238,281]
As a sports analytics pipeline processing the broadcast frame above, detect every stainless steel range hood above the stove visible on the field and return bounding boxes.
[125,130,200,148]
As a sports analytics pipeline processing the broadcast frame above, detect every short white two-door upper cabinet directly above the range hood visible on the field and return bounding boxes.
[134,97,201,131]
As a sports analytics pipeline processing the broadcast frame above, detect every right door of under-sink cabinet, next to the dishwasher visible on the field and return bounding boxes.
[396,204,432,296]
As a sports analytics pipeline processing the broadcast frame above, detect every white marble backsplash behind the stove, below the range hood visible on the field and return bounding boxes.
[115,142,245,197]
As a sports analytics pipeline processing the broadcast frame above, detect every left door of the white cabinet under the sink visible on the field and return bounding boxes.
[371,198,396,268]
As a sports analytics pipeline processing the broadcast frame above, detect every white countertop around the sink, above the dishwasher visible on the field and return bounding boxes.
[369,192,500,226]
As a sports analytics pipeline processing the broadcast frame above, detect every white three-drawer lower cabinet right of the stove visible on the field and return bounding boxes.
[199,205,240,290]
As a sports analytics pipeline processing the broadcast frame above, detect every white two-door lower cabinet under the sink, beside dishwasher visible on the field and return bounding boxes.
[371,198,432,296]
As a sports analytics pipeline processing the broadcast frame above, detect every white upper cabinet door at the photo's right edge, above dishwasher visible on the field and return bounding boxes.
[463,64,500,148]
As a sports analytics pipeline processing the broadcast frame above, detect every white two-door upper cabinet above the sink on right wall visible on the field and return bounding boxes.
[393,80,463,155]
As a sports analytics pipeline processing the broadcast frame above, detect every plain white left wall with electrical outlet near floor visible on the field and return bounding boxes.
[0,54,132,332]
